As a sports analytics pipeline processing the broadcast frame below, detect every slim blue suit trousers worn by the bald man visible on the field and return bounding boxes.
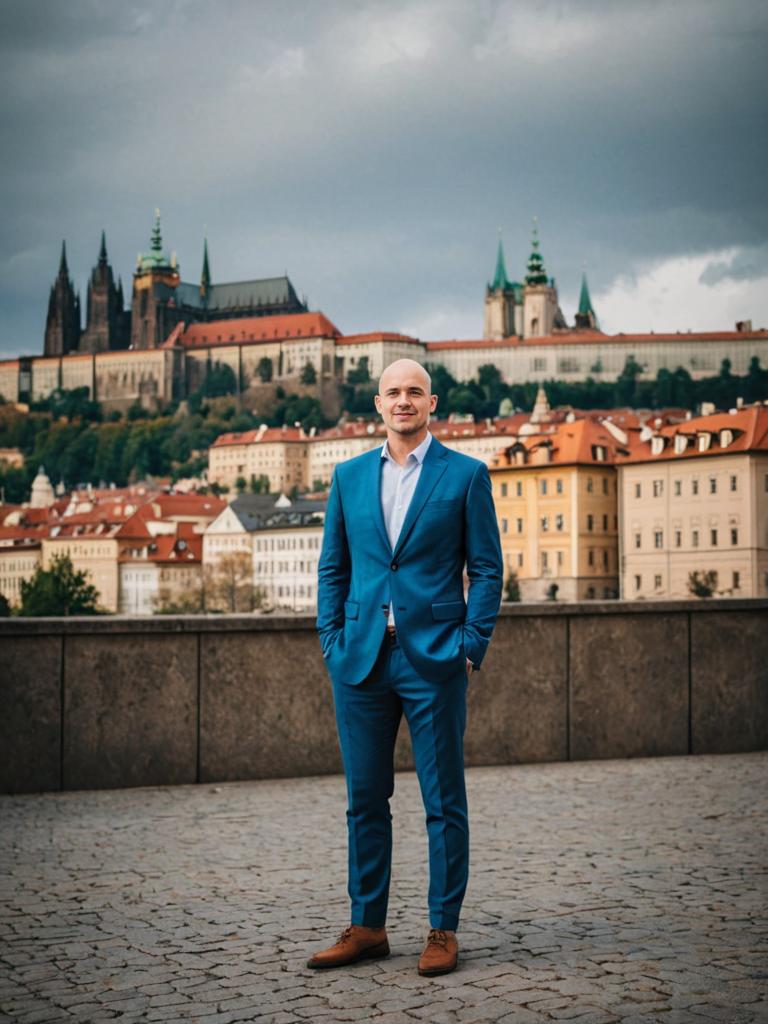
[334,636,469,931]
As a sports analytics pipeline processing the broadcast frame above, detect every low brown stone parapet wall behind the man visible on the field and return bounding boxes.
[0,599,768,793]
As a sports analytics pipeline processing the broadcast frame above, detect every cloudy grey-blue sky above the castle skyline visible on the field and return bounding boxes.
[0,0,768,356]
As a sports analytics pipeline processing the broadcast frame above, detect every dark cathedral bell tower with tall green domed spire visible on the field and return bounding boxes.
[131,210,182,348]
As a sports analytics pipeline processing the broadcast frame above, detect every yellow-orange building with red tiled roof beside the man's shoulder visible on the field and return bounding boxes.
[489,419,629,601]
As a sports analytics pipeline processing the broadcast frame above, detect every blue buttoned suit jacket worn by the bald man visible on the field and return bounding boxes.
[317,437,503,685]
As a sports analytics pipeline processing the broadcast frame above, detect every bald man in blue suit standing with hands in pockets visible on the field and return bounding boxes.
[307,359,502,975]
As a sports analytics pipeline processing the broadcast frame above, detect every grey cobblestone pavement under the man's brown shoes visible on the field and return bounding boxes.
[0,754,768,1024]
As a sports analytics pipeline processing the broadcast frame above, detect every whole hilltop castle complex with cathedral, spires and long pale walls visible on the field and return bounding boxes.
[0,212,768,410]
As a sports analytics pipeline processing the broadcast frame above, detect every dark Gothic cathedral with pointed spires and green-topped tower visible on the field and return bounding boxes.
[44,210,307,356]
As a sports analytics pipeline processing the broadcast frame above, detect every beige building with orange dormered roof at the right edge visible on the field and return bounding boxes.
[617,403,768,599]
